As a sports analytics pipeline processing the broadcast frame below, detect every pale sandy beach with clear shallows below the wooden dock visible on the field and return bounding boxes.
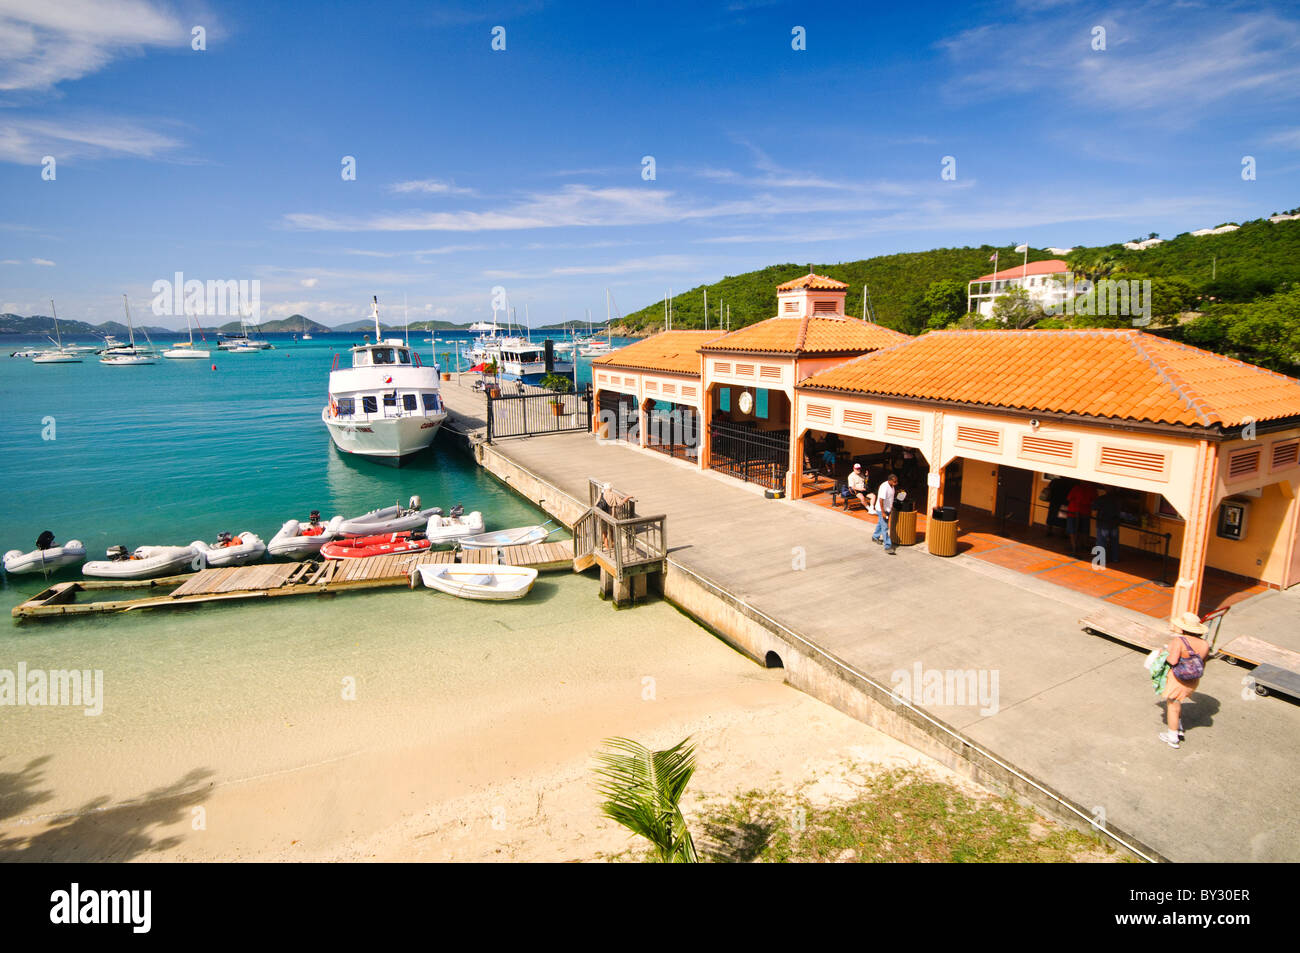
[0,577,954,861]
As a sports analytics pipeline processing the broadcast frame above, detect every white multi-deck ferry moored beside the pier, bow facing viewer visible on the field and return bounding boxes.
[321,298,447,464]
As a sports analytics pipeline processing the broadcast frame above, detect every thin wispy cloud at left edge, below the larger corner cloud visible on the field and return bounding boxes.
[0,116,181,164]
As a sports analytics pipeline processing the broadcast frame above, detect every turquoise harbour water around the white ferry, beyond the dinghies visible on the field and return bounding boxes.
[0,334,624,608]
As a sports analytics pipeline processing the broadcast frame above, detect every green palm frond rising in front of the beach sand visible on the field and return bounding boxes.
[595,737,699,863]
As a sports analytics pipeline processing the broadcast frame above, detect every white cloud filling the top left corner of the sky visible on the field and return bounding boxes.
[0,0,192,91]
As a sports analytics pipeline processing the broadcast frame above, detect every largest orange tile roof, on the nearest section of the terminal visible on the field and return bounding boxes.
[800,329,1300,426]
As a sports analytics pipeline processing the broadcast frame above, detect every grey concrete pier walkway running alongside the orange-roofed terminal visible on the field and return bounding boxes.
[445,374,1300,861]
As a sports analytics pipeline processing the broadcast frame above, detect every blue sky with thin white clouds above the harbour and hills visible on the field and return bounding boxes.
[0,0,1300,325]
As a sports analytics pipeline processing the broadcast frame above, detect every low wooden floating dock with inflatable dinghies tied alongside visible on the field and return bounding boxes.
[12,540,573,619]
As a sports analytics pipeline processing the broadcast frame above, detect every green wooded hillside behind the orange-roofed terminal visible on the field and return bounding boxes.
[623,218,1300,376]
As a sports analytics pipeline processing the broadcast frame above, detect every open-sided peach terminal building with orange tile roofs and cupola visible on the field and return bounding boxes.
[593,271,1300,616]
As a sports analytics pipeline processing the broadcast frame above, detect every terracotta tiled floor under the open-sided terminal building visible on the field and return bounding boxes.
[803,477,1268,619]
